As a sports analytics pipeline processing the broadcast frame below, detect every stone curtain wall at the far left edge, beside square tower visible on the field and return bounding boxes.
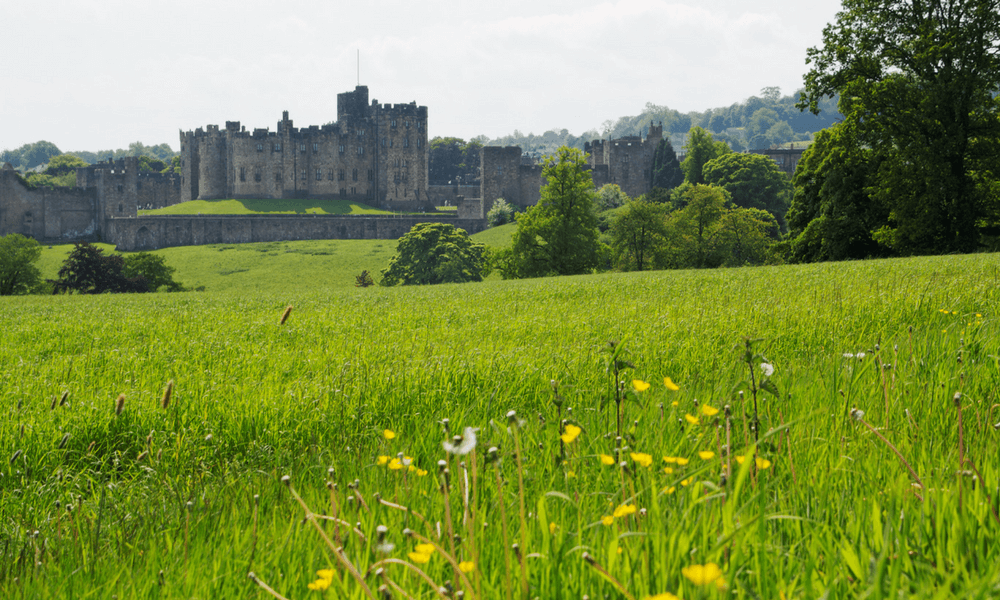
[0,165,100,242]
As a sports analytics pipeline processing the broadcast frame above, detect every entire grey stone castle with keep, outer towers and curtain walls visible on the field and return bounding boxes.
[0,86,663,251]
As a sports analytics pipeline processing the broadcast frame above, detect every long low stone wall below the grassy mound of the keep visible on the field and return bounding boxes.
[105,215,486,252]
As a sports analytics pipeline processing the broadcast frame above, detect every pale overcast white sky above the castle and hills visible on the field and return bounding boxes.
[0,0,840,151]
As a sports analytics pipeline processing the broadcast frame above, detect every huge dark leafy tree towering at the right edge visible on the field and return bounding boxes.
[798,0,1000,254]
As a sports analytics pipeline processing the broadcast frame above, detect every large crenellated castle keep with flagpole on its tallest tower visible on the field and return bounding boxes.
[180,86,433,211]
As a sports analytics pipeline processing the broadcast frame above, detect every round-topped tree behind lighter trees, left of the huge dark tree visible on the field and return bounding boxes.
[702,152,790,229]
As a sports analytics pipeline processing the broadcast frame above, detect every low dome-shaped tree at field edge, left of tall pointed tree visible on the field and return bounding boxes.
[379,223,486,286]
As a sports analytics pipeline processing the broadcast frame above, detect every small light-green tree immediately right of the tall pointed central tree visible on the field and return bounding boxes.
[611,198,667,271]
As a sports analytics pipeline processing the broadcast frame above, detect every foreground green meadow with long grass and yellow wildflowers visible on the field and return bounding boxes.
[0,249,1000,600]
